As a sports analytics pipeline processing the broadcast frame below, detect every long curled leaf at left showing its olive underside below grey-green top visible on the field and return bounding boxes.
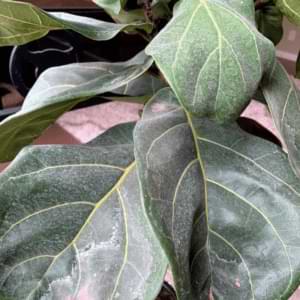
[0,52,152,162]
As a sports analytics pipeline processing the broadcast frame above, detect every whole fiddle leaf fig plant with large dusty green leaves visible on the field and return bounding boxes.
[0,0,300,300]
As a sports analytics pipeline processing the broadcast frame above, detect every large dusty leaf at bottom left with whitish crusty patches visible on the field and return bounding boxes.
[0,124,166,300]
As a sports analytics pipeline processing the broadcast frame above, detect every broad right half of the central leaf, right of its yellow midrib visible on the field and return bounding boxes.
[194,120,300,300]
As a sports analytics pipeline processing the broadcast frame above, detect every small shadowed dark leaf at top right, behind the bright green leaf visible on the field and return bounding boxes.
[255,4,283,45]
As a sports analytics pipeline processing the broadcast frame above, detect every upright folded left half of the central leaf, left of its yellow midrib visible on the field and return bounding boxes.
[134,89,210,299]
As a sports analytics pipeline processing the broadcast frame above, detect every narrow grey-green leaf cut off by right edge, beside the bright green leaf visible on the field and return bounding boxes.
[262,62,300,177]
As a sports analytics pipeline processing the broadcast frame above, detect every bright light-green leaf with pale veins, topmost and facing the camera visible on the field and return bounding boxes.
[146,0,275,123]
